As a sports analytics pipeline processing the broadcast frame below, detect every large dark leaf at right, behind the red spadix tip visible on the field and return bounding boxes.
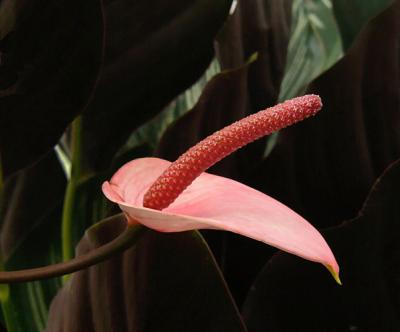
[251,5,400,227]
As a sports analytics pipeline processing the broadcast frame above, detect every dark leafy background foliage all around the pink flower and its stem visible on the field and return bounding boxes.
[0,0,400,332]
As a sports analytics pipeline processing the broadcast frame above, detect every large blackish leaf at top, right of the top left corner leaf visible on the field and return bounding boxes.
[83,0,231,170]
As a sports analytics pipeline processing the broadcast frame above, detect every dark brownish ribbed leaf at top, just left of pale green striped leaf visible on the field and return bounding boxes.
[217,0,292,106]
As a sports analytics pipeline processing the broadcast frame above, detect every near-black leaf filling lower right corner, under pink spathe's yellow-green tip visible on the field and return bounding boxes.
[244,161,400,332]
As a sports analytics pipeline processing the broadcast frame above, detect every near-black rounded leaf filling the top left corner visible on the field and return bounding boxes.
[0,0,103,177]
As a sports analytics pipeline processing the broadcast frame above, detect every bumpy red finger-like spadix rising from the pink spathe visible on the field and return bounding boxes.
[143,95,322,210]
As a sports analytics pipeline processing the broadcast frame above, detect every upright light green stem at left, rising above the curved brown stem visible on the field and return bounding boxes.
[61,117,82,272]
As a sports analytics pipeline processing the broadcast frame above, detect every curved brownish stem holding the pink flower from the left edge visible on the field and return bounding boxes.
[0,225,146,283]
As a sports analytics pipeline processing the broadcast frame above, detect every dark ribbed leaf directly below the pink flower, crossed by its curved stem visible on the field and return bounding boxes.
[47,218,246,332]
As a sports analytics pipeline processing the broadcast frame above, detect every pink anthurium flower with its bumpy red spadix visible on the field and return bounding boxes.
[102,95,340,283]
